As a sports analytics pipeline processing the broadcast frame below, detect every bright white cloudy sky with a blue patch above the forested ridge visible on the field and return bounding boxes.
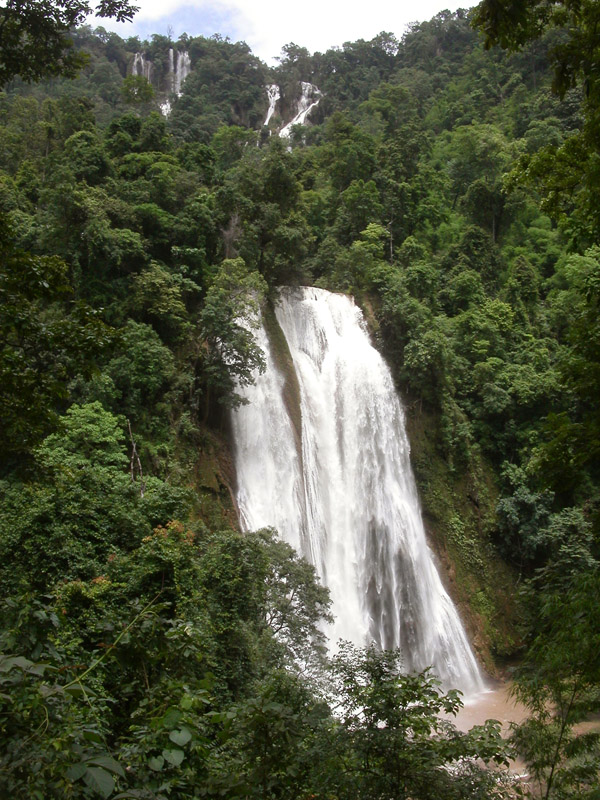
[98,0,474,64]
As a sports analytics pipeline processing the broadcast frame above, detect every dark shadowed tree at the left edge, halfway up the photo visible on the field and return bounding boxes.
[0,220,112,467]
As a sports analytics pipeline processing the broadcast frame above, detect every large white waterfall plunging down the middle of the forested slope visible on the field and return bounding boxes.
[233,288,483,693]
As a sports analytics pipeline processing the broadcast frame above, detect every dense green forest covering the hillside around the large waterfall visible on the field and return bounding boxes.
[0,0,600,800]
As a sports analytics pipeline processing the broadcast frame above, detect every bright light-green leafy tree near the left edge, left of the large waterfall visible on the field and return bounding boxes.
[0,402,185,592]
